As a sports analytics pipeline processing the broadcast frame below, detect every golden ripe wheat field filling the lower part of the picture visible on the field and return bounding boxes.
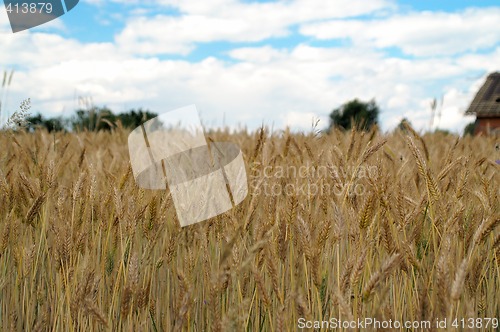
[0,127,500,331]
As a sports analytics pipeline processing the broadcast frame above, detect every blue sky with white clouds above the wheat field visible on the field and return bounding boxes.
[0,0,500,131]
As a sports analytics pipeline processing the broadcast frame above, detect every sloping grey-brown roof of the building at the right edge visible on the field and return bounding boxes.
[465,72,500,117]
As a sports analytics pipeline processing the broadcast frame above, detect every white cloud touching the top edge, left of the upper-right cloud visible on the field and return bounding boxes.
[116,0,390,55]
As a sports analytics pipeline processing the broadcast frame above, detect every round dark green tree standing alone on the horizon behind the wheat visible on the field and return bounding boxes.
[330,99,380,130]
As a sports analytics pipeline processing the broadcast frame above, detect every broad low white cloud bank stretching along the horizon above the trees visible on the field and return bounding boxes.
[3,35,494,130]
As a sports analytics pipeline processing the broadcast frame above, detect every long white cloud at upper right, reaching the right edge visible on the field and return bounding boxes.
[300,7,500,56]
